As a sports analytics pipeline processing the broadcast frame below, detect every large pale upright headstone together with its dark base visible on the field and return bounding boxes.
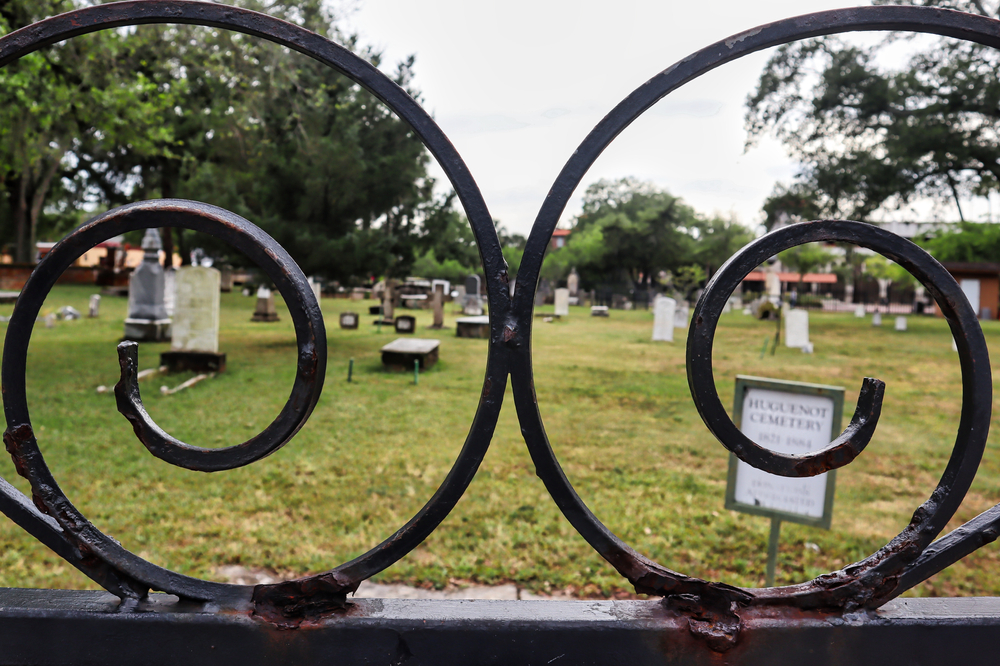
[160,266,226,372]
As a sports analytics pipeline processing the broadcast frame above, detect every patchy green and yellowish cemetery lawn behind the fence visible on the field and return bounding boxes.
[0,286,1000,597]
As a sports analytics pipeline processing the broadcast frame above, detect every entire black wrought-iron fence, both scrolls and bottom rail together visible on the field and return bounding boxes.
[0,0,1000,663]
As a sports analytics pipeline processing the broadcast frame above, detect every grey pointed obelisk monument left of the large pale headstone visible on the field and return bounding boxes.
[125,229,170,342]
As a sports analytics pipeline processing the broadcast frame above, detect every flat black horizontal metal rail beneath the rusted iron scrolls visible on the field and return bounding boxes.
[0,588,1000,666]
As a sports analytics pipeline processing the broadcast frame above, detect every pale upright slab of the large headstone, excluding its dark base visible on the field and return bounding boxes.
[170,266,220,352]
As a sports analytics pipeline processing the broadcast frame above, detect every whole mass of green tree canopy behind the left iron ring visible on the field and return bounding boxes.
[0,0,479,281]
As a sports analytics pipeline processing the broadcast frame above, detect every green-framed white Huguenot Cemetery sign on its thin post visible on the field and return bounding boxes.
[726,375,844,587]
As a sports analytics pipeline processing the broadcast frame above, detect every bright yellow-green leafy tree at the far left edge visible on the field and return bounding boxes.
[0,0,172,262]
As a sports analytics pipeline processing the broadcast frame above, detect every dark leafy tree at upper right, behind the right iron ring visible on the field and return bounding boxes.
[746,0,1000,220]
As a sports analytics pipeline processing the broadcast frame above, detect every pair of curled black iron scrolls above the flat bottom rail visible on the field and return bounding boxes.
[0,0,1000,632]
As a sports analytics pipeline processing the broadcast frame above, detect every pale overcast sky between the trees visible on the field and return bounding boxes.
[344,0,880,235]
